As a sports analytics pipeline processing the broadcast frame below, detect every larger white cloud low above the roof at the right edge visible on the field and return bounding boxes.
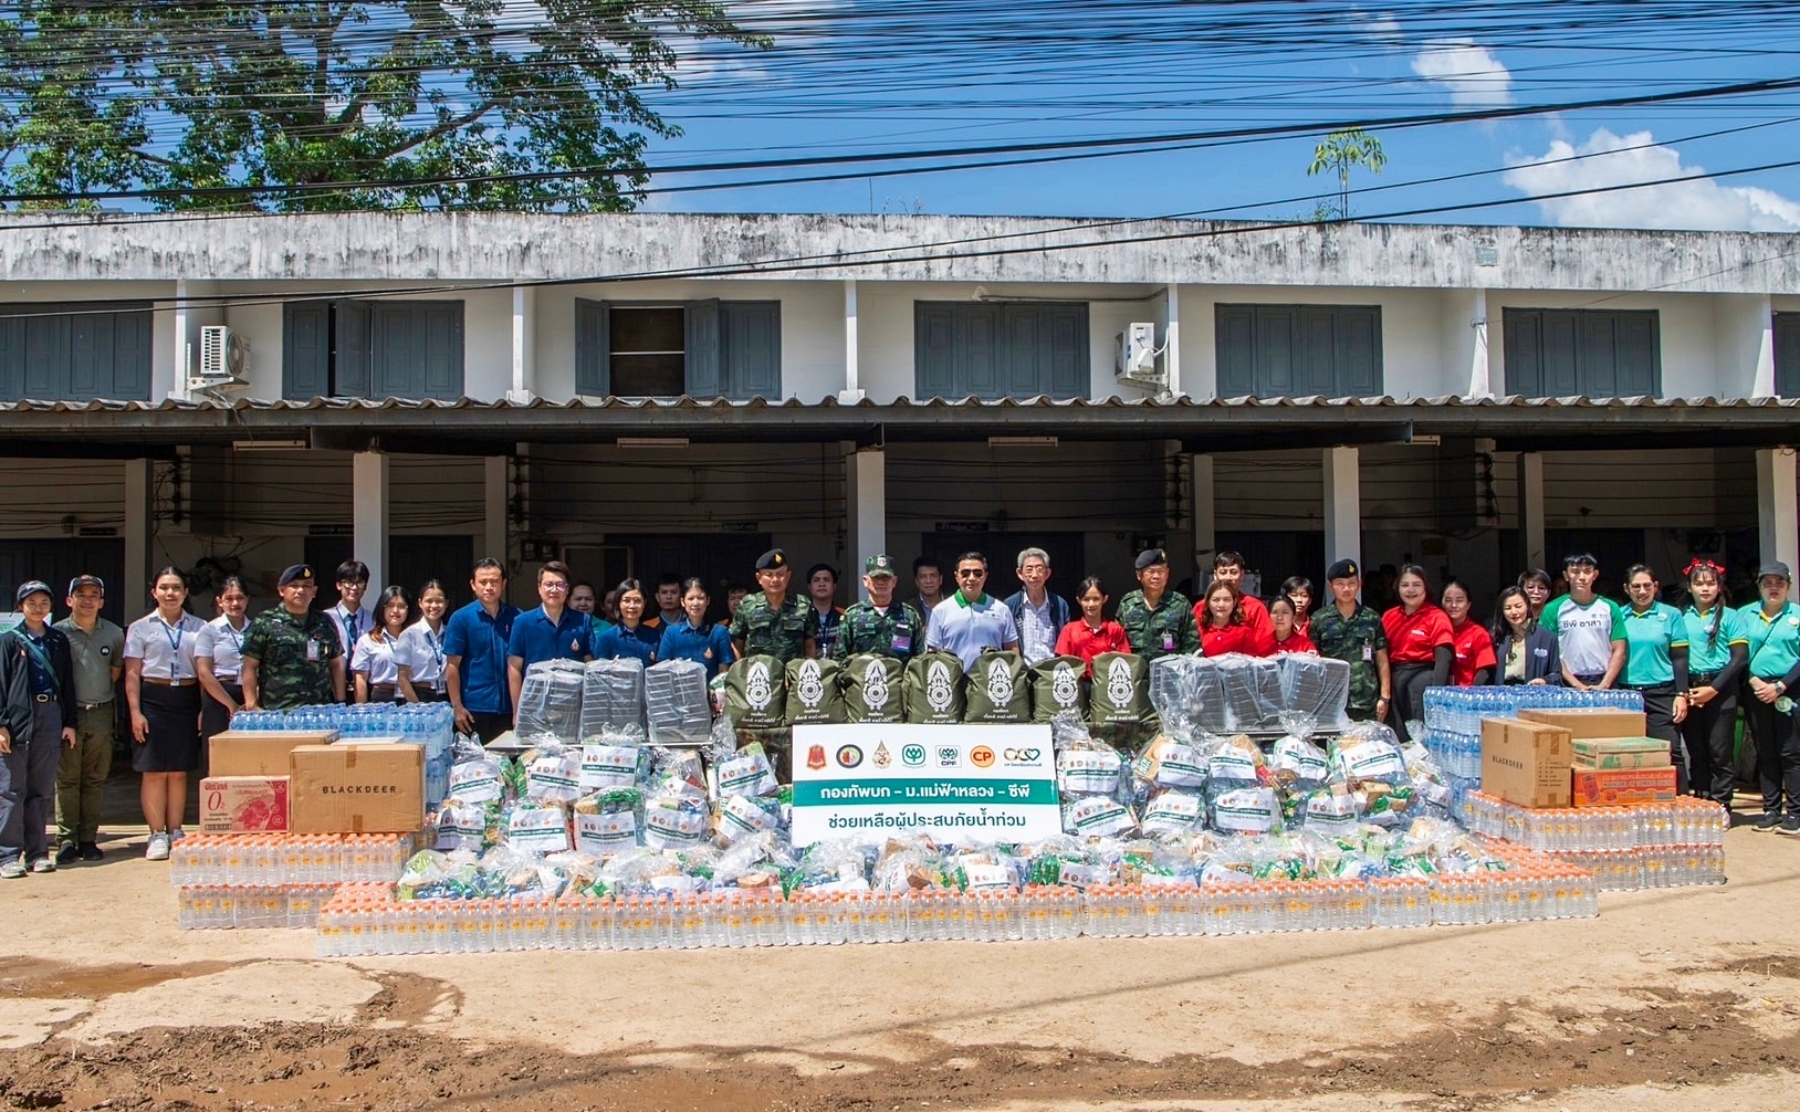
[1505,128,1800,232]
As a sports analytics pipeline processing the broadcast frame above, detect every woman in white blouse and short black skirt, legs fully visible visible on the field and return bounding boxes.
[124,567,205,860]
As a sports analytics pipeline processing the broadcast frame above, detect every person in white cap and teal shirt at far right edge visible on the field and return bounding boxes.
[1739,560,1800,835]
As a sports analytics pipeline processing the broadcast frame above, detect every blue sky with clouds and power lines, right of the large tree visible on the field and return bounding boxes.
[615,0,1800,230]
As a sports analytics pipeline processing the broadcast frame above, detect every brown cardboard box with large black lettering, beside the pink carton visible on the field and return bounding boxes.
[288,745,425,833]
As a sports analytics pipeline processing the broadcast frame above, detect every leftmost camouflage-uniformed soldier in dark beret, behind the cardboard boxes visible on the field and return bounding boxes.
[238,563,344,711]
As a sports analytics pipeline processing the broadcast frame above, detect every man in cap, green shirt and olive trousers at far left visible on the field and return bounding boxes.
[56,576,124,865]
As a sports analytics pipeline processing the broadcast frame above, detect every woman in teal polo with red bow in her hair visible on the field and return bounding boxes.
[1681,560,1750,808]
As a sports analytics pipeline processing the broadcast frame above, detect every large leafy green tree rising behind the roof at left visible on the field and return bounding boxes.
[0,0,770,212]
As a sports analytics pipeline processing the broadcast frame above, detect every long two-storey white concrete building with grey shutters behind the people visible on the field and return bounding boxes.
[0,214,1800,614]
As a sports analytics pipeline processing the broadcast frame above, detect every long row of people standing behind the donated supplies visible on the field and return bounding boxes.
[0,547,1800,878]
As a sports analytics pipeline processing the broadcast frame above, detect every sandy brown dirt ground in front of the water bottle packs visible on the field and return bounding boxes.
[0,791,1800,1112]
